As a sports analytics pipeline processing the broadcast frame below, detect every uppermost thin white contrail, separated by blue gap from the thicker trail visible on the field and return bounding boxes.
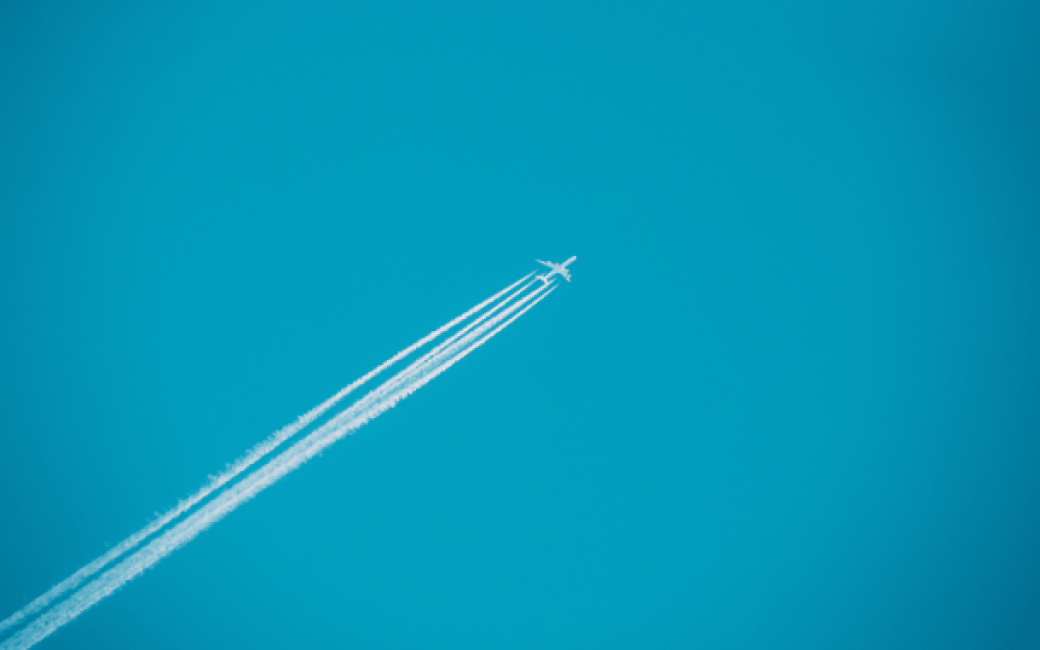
[0,274,534,632]
